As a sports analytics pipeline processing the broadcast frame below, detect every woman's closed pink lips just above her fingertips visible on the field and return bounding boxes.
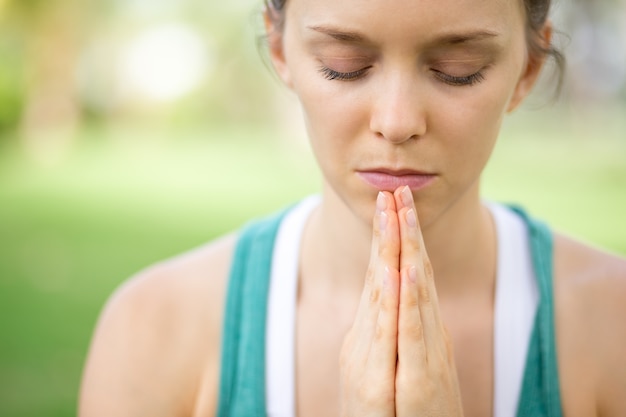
[357,168,437,192]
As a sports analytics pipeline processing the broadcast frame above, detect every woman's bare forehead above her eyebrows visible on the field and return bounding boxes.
[287,0,525,43]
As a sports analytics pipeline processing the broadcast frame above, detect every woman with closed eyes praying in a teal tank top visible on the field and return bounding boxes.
[80,0,626,417]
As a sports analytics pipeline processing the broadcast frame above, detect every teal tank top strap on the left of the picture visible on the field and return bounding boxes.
[217,210,288,417]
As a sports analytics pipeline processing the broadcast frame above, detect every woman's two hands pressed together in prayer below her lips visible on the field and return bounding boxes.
[340,187,463,416]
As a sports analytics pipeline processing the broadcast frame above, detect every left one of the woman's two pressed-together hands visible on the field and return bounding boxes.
[341,193,400,415]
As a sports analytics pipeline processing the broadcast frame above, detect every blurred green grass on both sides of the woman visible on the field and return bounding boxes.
[0,119,626,417]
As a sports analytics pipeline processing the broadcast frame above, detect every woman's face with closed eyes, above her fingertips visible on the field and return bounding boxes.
[270,0,541,226]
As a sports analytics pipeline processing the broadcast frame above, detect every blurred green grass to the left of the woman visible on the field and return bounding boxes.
[0,125,318,417]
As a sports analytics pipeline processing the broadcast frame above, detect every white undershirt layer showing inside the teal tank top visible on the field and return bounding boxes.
[265,200,539,417]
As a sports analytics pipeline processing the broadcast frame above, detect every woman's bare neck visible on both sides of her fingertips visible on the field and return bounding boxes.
[301,184,497,297]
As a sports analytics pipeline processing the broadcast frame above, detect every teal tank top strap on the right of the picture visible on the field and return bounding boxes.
[512,207,562,417]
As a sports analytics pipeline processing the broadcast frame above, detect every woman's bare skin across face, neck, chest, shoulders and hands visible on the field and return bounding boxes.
[79,0,626,417]
